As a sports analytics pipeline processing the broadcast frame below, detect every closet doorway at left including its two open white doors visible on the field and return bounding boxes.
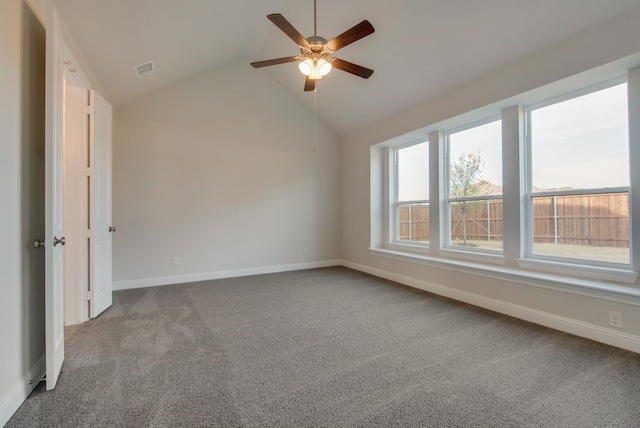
[45,3,115,390]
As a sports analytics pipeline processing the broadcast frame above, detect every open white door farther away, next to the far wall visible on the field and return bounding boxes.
[89,90,115,318]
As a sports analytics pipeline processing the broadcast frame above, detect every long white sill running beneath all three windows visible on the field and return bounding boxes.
[369,248,640,306]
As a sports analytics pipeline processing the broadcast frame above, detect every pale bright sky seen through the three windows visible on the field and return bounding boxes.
[398,84,629,201]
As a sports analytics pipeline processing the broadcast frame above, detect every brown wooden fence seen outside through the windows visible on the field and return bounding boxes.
[399,193,629,248]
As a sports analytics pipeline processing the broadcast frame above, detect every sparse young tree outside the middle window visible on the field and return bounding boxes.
[449,152,486,245]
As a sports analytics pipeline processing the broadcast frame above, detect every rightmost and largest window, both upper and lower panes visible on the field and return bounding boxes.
[527,83,630,264]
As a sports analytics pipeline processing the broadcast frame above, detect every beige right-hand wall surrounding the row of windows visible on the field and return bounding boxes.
[341,8,640,351]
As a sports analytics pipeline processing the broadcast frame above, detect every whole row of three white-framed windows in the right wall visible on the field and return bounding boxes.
[370,72,640,288]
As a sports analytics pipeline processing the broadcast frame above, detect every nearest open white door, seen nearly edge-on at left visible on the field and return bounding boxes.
[45,4,65,390]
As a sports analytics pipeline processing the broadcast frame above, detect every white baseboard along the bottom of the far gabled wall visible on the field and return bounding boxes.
[113,260,342,291]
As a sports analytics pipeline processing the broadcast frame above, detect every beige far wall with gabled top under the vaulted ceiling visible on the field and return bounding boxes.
[113,61,340,288]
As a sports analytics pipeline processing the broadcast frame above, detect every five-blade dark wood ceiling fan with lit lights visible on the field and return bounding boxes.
[251,0,375,91]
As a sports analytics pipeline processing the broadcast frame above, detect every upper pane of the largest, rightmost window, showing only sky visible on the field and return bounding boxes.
[531,84,629,192]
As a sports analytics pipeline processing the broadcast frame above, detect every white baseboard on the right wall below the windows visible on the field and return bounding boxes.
[342,260,640,353]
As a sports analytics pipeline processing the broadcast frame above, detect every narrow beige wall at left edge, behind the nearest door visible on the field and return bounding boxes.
[0,0,45,424]
